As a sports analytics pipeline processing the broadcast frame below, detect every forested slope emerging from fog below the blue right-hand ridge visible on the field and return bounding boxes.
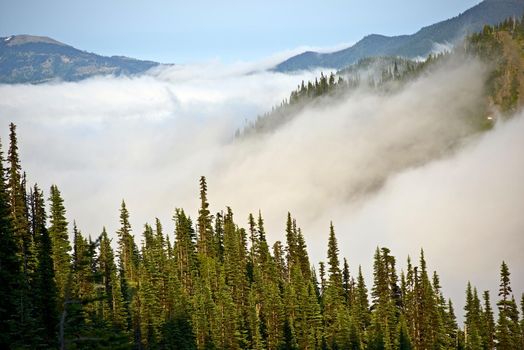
[236,18,524,137]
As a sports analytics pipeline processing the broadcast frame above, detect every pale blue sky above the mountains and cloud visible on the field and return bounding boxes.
[0,0,479,63]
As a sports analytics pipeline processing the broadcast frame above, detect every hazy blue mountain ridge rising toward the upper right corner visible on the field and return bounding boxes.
[273,0,524,72]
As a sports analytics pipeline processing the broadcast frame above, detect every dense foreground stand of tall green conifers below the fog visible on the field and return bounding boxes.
[0,124,524,350]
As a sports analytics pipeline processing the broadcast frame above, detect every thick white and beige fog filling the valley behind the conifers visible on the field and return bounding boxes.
[0,56,524,315]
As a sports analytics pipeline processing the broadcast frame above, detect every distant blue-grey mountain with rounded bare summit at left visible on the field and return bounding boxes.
[0,35,159,84]
